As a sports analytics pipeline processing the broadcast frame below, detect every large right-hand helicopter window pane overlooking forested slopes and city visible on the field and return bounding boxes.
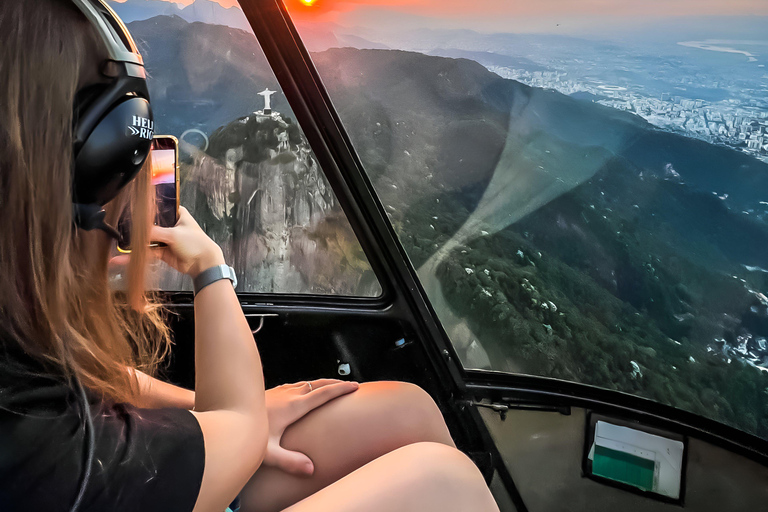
[289,0,768,439]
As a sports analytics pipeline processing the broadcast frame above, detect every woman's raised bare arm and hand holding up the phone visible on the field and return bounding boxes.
[151,208,269,511]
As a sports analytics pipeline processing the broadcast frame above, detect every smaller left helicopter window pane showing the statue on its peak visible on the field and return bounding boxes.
[111,0,381,296]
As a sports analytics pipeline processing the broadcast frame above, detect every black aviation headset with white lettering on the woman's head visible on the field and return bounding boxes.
[72,0,154,238]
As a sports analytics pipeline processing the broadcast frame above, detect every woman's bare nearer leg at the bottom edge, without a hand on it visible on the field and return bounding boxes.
[286,443,499,512]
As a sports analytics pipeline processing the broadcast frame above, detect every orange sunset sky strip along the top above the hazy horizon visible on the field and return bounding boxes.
[111,0,768,33]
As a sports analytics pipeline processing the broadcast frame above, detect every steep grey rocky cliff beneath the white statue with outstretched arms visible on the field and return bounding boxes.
[175,111,379,295]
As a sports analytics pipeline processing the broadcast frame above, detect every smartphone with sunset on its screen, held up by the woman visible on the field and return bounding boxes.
[117,135,179,253]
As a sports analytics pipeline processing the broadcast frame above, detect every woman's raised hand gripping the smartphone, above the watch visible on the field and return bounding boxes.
[149,206,224,279]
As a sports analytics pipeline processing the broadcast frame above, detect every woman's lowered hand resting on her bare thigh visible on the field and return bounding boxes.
[264,379,359,476]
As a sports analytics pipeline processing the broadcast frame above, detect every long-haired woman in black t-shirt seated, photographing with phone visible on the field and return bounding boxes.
[0,0,498,512]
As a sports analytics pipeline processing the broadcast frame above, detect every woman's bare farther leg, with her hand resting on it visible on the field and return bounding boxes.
[240,382,454,512]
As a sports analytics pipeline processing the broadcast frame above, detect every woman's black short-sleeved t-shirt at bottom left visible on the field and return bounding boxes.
[0,350,205,512]
